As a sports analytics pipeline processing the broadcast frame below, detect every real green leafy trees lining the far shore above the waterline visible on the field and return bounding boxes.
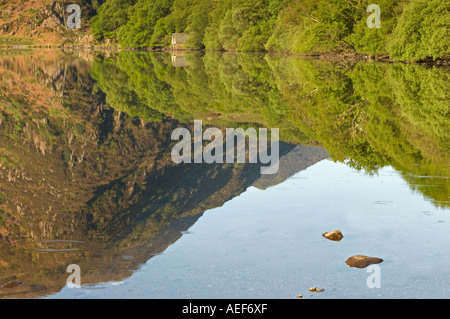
[92,0,450,59]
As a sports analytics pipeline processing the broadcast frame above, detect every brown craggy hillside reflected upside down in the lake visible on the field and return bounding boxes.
[0,56,328,297]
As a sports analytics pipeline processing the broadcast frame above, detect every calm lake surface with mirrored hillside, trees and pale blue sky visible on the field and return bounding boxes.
[0,51,450,299]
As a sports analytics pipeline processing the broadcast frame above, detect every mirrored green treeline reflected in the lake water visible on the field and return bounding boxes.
[93,52,450,208]
